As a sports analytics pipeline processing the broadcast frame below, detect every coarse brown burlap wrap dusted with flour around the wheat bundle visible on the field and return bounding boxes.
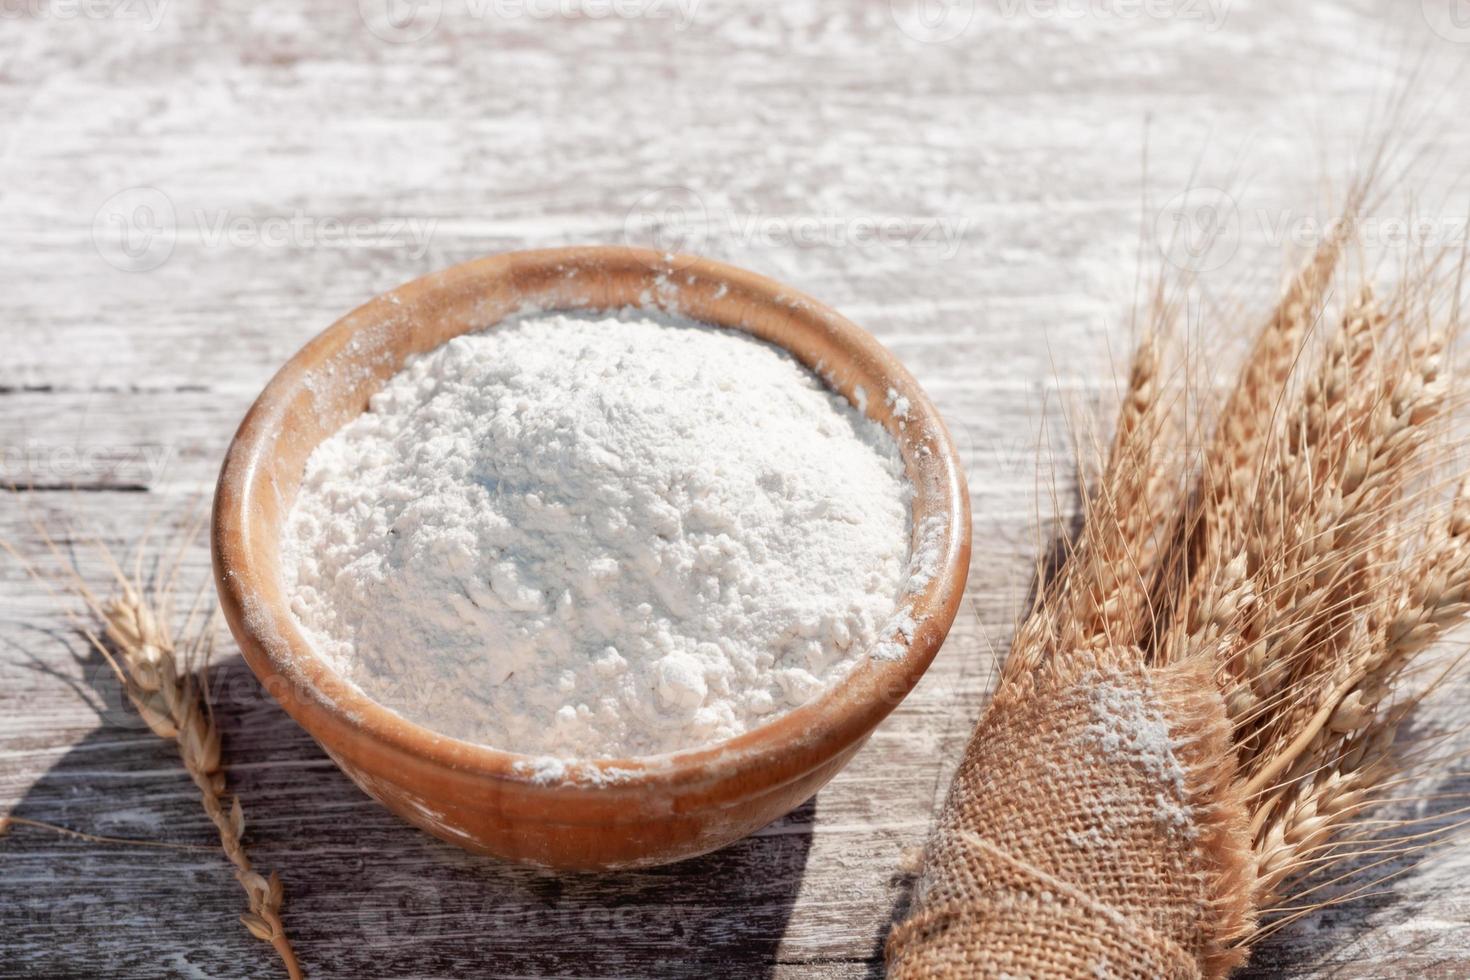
[888,649,1251,980]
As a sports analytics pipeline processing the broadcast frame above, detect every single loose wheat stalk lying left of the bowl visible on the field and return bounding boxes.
[0,527,303,980]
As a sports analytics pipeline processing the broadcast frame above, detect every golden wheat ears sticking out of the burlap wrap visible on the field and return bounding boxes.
[1040,195,1470,963]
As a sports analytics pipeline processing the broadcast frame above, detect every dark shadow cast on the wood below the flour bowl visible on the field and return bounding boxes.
[0,657,816,979]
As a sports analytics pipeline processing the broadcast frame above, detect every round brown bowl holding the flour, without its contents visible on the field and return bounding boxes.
[212,247,970,868]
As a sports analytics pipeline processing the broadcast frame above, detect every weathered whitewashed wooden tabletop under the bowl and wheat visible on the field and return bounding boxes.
[0,0,1470,979]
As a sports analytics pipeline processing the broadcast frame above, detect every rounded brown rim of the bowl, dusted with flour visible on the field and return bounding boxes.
[210,245,970,823]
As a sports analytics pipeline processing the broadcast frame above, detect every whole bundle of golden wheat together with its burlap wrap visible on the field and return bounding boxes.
[888,153,1470,977]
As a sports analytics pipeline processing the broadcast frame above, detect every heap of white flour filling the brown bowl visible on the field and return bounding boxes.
[282,313,913,758]
